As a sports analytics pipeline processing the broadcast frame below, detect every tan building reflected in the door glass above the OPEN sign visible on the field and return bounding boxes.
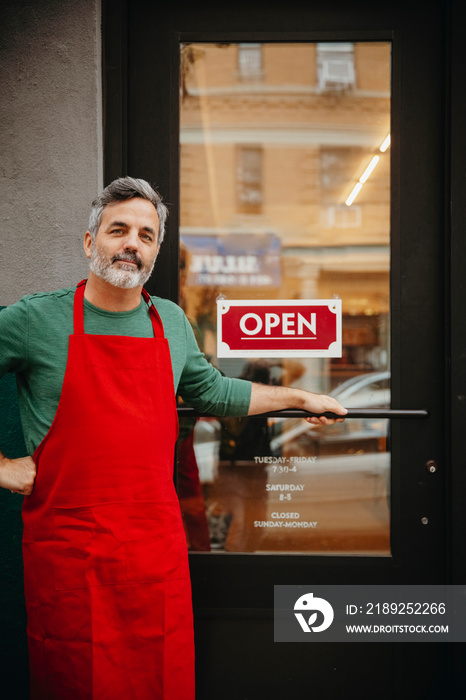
[180,43,390,390]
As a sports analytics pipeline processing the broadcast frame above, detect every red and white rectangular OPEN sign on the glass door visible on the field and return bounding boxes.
[217,299,341,357]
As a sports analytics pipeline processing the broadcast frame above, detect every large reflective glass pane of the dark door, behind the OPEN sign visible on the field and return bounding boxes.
[178,42,390,555]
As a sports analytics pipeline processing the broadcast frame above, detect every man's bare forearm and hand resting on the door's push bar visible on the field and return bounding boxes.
[248,382,347,425]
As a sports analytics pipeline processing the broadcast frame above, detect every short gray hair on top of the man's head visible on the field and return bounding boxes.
[89,176,168,245]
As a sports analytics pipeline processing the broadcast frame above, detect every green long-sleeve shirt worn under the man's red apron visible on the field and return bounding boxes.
[0,287,251,454]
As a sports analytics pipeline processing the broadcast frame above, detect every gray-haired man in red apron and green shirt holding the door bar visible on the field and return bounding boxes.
[0,177,346,700]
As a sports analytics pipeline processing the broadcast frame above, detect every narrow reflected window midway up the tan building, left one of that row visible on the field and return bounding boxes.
[236,146,262,214]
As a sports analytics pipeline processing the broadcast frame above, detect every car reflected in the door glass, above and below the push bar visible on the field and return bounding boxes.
[271,371,390,456]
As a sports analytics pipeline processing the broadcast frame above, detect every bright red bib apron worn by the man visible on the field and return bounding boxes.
[23,282,194,700]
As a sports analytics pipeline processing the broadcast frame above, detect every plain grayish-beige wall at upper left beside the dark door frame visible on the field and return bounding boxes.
[0,0,102,305]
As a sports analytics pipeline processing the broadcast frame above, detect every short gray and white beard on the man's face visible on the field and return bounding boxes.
[89,241,155,289]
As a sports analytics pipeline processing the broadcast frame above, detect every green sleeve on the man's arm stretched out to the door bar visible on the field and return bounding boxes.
[179,314,251,416]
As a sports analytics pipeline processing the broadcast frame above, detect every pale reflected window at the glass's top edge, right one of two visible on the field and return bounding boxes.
[317,43,356,92]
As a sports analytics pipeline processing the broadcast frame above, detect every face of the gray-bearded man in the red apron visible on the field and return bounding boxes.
[84,197,159,289]
